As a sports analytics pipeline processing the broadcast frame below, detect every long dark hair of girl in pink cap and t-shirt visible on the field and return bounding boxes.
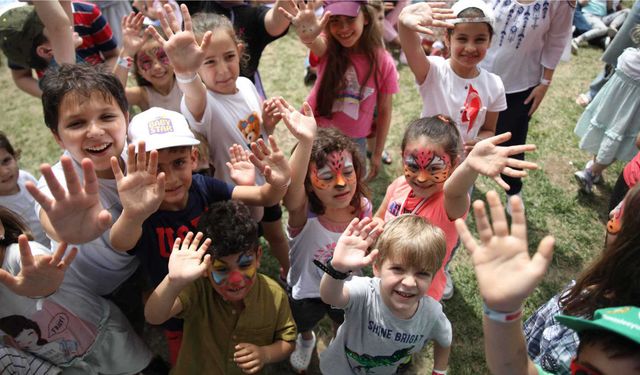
[315,4,384,118]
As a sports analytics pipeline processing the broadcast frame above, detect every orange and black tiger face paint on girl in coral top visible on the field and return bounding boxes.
[403,148,451,183]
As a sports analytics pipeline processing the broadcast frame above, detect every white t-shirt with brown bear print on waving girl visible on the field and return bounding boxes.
[180,77,267,185]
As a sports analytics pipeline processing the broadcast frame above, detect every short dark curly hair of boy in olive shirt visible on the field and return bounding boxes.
[198,200,258,259]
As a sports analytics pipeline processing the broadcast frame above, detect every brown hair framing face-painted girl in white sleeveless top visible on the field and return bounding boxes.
[304,128,369,216]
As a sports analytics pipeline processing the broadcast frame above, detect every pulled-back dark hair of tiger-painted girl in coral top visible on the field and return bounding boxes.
[400,115,461,163]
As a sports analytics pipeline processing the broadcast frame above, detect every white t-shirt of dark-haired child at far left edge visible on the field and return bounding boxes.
[0,170,49,246]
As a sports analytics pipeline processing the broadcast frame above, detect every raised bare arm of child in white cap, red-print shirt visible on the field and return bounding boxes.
[398,3,455,85]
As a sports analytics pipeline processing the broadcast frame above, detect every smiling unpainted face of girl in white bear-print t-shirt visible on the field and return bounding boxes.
[198,28,243,95]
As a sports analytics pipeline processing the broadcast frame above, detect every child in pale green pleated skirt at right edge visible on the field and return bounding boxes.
[574,45,640,194]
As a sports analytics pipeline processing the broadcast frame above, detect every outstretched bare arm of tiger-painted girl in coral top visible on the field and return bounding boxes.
[444,133,538,220]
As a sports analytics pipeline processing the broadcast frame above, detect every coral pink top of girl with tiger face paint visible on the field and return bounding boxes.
[384,176,467,301]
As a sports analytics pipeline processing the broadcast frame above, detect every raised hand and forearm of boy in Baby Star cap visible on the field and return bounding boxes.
[109,142,165,251]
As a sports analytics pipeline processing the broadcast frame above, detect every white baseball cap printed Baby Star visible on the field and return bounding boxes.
[128,107,200,152]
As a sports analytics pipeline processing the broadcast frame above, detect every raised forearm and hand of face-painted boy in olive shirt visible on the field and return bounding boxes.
[144,232,211,324]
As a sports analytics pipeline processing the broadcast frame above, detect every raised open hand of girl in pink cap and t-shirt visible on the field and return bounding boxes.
[278,0,331,44]
